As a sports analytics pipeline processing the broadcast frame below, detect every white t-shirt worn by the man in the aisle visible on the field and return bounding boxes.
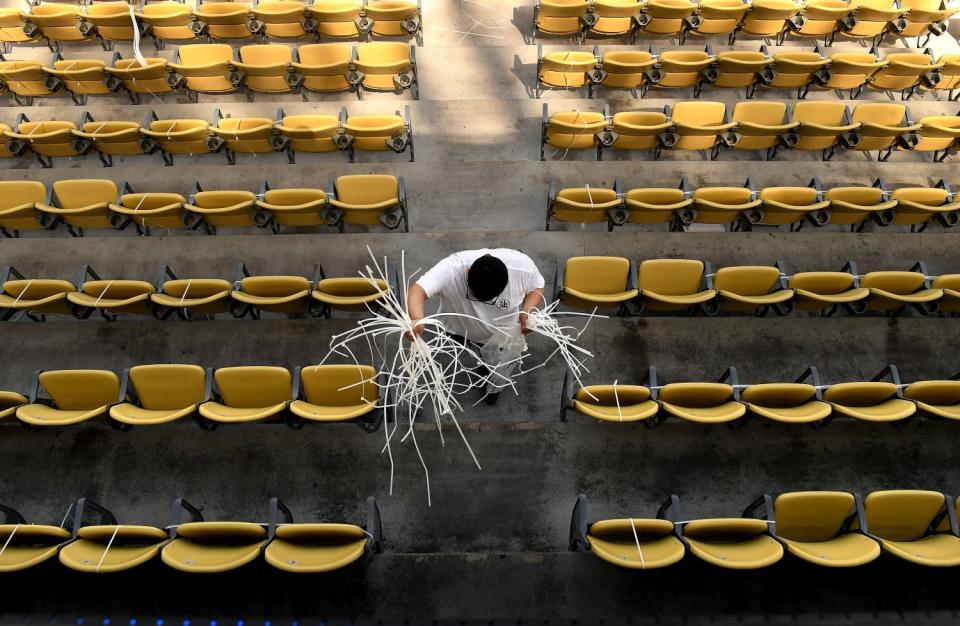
[417,248,544,344]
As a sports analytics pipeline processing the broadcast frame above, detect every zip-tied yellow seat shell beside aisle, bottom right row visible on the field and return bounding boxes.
[587,519,686,569]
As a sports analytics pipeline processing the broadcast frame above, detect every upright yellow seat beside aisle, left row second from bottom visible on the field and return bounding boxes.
[290,364,380,430]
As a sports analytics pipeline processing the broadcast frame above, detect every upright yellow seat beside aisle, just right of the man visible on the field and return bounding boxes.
[553,256,638,315]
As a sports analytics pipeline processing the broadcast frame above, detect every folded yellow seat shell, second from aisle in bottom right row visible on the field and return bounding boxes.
[683,518,783,569]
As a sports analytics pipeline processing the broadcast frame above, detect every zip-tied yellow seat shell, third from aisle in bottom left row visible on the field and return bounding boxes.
[60,524,167,574]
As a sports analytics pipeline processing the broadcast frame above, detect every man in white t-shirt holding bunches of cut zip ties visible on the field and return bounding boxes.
[407,248,543,404]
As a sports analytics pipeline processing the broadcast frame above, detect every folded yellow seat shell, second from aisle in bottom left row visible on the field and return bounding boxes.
[160,522,267,574]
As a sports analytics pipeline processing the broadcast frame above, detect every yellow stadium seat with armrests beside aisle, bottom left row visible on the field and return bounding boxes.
[263,497,383,574]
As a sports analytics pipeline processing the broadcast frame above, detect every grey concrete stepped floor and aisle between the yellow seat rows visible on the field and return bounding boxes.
[0,0,960,624]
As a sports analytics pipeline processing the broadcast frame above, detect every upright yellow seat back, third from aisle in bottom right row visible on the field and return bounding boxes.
[773,491,856,542]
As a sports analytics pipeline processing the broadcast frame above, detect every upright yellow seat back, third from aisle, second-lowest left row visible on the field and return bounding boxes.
[130,363,207,411]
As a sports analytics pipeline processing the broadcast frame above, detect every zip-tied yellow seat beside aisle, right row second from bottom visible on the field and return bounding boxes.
[560,369,660,428]
